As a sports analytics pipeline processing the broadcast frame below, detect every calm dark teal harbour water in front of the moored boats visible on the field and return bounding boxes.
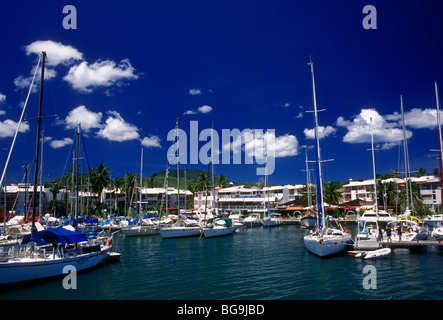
[0,225,443,300]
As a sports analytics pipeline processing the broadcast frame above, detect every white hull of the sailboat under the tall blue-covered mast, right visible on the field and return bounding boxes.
[304,235,351,257]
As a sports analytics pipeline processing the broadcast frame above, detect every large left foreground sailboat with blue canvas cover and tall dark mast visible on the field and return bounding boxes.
[0,52,112,284]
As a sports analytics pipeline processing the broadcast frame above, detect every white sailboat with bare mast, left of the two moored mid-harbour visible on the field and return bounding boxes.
[160,118,202,239]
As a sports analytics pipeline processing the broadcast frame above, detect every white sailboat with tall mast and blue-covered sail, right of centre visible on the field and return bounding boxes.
[303,61,352,257]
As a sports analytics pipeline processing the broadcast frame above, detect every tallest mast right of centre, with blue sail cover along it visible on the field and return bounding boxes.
[308,61,325,231]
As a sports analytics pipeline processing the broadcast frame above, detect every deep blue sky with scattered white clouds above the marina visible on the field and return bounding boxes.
[0,0,443,184]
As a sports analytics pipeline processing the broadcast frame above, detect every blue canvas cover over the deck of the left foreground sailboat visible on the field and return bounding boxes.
[22,227,88,246]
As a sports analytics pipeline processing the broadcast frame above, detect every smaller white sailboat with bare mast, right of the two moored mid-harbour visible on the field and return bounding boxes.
[203,128,236,238]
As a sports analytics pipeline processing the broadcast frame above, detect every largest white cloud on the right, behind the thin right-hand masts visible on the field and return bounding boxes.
[336,109,412,149]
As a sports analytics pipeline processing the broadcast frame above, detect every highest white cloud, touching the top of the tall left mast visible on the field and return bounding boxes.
[25,40,83,66]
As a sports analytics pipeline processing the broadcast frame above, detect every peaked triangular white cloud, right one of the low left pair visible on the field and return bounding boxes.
[97,111,140,142]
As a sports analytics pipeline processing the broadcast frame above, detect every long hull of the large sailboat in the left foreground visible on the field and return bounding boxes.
[0,247,111,284]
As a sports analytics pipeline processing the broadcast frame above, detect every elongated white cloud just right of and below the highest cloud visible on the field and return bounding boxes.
[63,59,138,93]
